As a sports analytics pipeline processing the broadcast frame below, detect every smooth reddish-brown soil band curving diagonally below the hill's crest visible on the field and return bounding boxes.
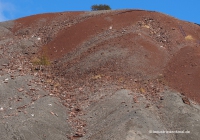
[40,10,180,59]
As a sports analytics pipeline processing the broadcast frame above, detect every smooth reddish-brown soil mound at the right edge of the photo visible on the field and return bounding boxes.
[165,47,200,102]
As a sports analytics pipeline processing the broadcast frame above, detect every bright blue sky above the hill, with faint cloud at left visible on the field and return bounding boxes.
[0,0,200,24]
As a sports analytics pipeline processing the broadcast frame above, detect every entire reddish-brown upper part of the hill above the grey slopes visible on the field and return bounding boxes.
[13,10,200,105]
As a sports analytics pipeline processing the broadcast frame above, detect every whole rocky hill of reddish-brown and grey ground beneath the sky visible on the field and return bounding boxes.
[0,10,200,140]
